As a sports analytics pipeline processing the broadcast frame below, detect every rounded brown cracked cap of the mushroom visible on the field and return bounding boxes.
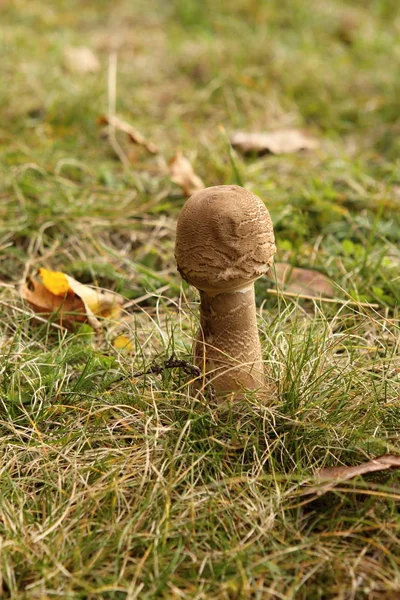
[175,185,276,295]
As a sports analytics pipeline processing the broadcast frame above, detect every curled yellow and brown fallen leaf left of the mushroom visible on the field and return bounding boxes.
[21,269,121,330]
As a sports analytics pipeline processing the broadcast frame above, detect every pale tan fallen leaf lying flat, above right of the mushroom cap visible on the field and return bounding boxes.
[231,129,319,154]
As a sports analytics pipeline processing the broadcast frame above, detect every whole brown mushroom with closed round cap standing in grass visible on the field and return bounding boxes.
[175,185,276,395]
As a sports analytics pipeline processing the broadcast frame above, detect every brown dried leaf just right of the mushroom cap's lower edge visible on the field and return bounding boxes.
[270,263,335,298]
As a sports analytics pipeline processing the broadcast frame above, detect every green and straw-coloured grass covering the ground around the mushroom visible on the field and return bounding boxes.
[0,0,400,600]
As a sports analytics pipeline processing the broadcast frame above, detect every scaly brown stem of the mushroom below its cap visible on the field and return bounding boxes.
[194,283,265,394]
